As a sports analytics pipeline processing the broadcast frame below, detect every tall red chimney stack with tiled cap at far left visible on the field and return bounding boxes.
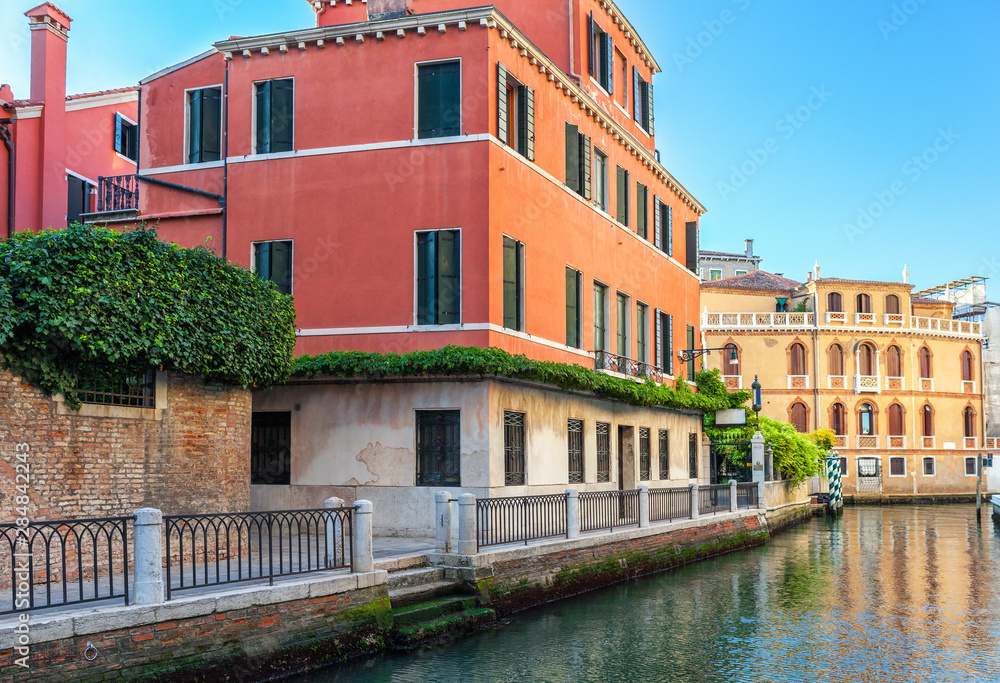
[24,3,72,228]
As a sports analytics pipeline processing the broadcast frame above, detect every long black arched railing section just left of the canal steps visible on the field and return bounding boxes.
[163,507,354,600]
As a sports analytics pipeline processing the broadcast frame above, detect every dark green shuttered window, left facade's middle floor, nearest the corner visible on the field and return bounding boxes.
[417,230,462,325]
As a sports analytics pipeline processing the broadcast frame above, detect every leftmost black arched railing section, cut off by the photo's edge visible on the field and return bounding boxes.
[0,517,133,614]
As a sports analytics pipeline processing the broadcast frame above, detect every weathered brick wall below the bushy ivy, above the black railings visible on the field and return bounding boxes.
[0,370,251,522]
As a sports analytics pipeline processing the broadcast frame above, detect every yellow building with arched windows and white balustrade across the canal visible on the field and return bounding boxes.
[701,267,997,495]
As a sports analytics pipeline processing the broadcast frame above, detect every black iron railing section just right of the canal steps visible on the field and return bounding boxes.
[476,493,568,548]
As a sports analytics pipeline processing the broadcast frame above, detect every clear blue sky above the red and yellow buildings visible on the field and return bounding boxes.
[0,0,1000,298]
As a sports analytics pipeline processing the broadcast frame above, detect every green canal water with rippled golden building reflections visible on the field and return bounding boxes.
[295,506,1000,683]
